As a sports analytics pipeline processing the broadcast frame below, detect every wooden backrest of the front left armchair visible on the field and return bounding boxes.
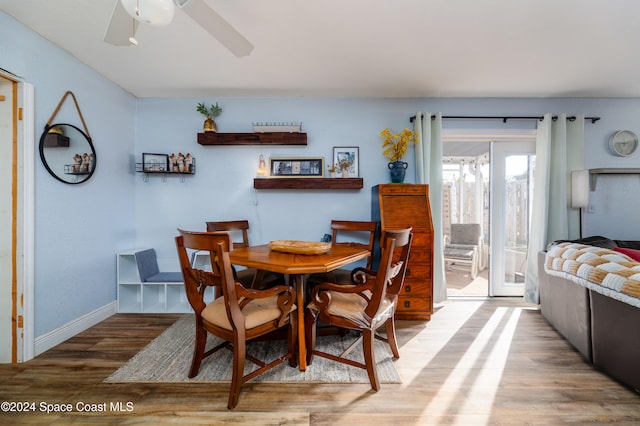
[176,229,235,315]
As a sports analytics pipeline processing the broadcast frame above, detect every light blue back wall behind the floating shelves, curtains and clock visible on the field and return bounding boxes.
[136,98,640,257]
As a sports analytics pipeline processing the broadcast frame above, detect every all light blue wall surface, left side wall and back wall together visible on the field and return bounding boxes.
[0,12,640,336]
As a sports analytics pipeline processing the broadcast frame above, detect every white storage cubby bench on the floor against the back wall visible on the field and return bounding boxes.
[117,249,213,313]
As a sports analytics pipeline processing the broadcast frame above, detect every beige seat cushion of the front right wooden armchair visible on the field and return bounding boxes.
[309,291,394,328]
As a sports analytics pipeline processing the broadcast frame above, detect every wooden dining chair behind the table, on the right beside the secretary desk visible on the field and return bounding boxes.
[307,220,378,289]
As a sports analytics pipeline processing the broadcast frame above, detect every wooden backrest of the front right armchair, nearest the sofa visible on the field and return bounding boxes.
[365,228,413,318]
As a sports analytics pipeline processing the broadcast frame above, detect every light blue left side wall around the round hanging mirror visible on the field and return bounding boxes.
[0,12,136,336]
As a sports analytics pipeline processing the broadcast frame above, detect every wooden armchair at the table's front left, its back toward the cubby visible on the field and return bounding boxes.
[175,230,297,409]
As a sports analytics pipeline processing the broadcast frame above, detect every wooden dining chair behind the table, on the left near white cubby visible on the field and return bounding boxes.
[206,220,286,288]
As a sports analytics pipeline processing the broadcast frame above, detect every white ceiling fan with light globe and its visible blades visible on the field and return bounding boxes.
[104,0,253,57]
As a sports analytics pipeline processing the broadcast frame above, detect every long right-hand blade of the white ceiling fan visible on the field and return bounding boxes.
[176,0,253,58]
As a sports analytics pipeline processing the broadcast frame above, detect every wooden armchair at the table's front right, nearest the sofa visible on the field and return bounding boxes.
[305,228,412,391]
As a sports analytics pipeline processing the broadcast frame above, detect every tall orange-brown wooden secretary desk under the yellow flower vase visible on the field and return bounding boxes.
[371,184,433,320]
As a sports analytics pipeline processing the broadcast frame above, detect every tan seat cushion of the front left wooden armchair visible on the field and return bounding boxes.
[202,295,290,330]
